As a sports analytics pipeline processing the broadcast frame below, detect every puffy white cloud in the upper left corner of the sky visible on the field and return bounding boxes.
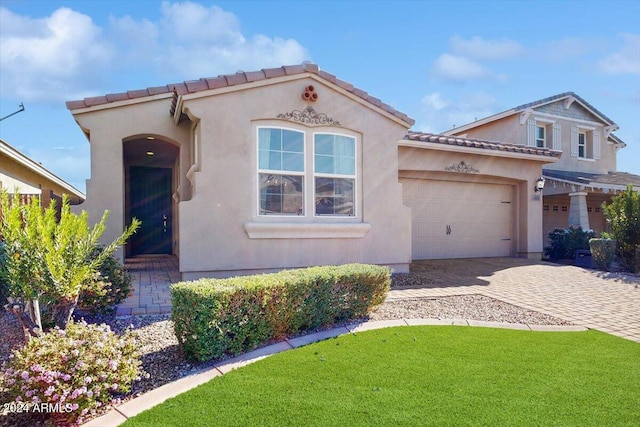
[0,8,112,101]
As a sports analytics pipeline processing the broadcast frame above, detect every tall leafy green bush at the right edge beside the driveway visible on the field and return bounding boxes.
[602,185,640,271]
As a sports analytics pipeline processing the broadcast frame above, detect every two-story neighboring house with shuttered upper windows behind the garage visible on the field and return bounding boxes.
[444,92,640,241]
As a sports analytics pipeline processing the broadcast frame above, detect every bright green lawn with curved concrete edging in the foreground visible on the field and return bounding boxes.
[124,326,640,427]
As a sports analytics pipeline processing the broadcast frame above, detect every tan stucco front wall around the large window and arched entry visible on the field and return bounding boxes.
[74,75,411,279]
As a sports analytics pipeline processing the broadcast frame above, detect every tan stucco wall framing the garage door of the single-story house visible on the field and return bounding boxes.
[399,144,543,258]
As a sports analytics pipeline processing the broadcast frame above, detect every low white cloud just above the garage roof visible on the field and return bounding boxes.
[415,92,497,133]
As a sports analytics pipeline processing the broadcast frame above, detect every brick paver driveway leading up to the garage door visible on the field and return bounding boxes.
[388,258,640,342]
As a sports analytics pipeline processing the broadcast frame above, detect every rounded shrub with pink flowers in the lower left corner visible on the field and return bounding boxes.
[0,321,142,425]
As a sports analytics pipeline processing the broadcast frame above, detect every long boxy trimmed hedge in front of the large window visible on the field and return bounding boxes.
[171,264,391,361]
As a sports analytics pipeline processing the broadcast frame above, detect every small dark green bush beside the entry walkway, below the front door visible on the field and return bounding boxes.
[78,248,131,313]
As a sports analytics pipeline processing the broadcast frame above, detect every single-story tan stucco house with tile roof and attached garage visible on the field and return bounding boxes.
[67,64,559,279]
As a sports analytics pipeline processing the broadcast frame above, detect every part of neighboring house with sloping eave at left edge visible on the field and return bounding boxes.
[0,139,85,207]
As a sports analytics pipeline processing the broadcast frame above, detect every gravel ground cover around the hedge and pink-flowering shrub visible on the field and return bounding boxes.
[0,274,571,427]
